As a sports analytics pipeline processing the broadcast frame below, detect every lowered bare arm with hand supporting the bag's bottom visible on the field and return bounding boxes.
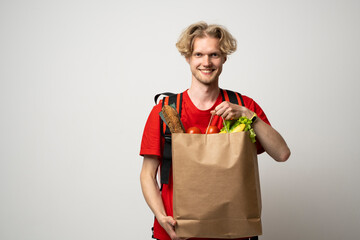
[140,155,178,240]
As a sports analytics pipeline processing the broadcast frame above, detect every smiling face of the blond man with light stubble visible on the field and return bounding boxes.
[186,37,226,85]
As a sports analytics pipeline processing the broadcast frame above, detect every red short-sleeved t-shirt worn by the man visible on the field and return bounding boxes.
[140,91,270,240]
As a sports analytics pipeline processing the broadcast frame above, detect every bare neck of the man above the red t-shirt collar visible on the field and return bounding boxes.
[188,82,220,110]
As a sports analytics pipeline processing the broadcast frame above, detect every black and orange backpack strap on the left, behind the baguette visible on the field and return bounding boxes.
[155,93,183,185]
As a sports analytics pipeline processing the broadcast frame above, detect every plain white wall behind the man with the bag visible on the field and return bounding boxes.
[0,0,360,240]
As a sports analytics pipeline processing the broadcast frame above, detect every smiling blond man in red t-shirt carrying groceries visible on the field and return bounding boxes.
[140,22,290,240]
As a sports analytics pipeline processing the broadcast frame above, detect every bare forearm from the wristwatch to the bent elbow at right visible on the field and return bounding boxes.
[253,118,290,162]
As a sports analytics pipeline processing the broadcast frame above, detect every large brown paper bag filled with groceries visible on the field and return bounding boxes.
[172,132,262,239]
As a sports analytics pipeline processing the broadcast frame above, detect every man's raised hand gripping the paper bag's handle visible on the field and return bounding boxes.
[211,101,254,120]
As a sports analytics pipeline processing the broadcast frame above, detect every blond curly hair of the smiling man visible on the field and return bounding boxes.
[176,22,236,58]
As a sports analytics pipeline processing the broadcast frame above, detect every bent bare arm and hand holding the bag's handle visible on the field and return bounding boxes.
[213,102,290,162]
